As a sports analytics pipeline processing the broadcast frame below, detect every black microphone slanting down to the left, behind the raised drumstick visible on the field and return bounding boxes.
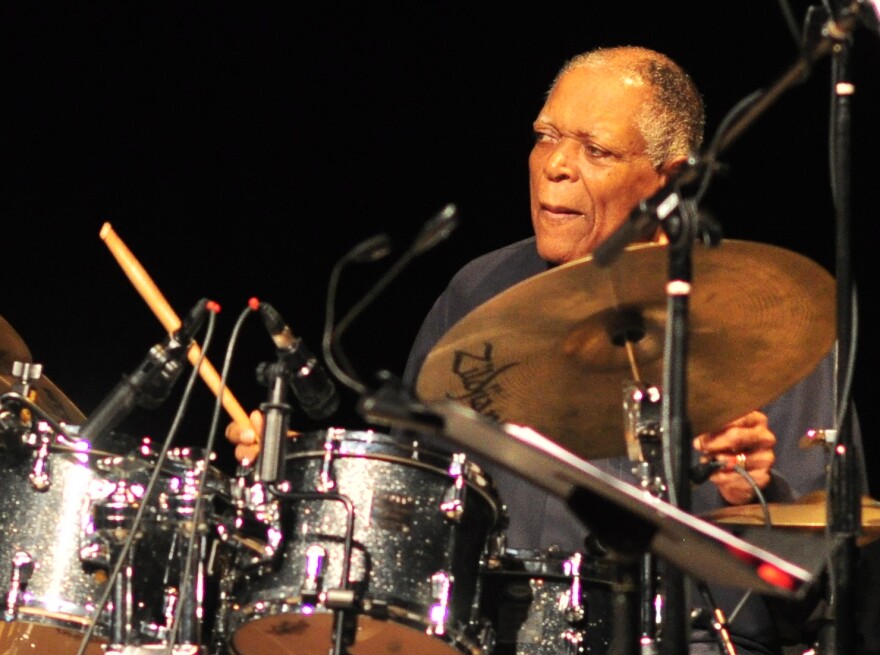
[79,298,214,441]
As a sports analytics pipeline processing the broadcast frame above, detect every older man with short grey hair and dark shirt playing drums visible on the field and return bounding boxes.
[226,46,866,654]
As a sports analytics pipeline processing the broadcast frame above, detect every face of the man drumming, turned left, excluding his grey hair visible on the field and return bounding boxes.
[529,67,666,264]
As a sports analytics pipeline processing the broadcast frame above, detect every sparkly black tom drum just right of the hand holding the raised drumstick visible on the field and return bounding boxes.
[228,429,503,655]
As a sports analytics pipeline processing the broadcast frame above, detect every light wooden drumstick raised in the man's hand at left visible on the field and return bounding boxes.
[100,223,254,430]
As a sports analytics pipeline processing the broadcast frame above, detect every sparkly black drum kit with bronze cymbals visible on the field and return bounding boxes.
[0,234,880,655]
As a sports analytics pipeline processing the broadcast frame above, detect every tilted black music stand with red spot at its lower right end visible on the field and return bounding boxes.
[359,391,836,599]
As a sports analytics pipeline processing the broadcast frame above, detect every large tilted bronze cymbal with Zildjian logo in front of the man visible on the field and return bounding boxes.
[416,240,836,459]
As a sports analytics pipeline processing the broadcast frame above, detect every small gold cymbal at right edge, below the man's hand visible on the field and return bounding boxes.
[703,491,880,546]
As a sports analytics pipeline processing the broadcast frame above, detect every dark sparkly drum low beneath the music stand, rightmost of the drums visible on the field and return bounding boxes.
[480,550,638,655]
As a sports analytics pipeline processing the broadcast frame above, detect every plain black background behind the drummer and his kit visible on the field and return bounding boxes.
[0,0,880,495]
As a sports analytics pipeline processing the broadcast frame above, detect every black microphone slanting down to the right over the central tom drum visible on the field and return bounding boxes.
[259,302,339,419]
